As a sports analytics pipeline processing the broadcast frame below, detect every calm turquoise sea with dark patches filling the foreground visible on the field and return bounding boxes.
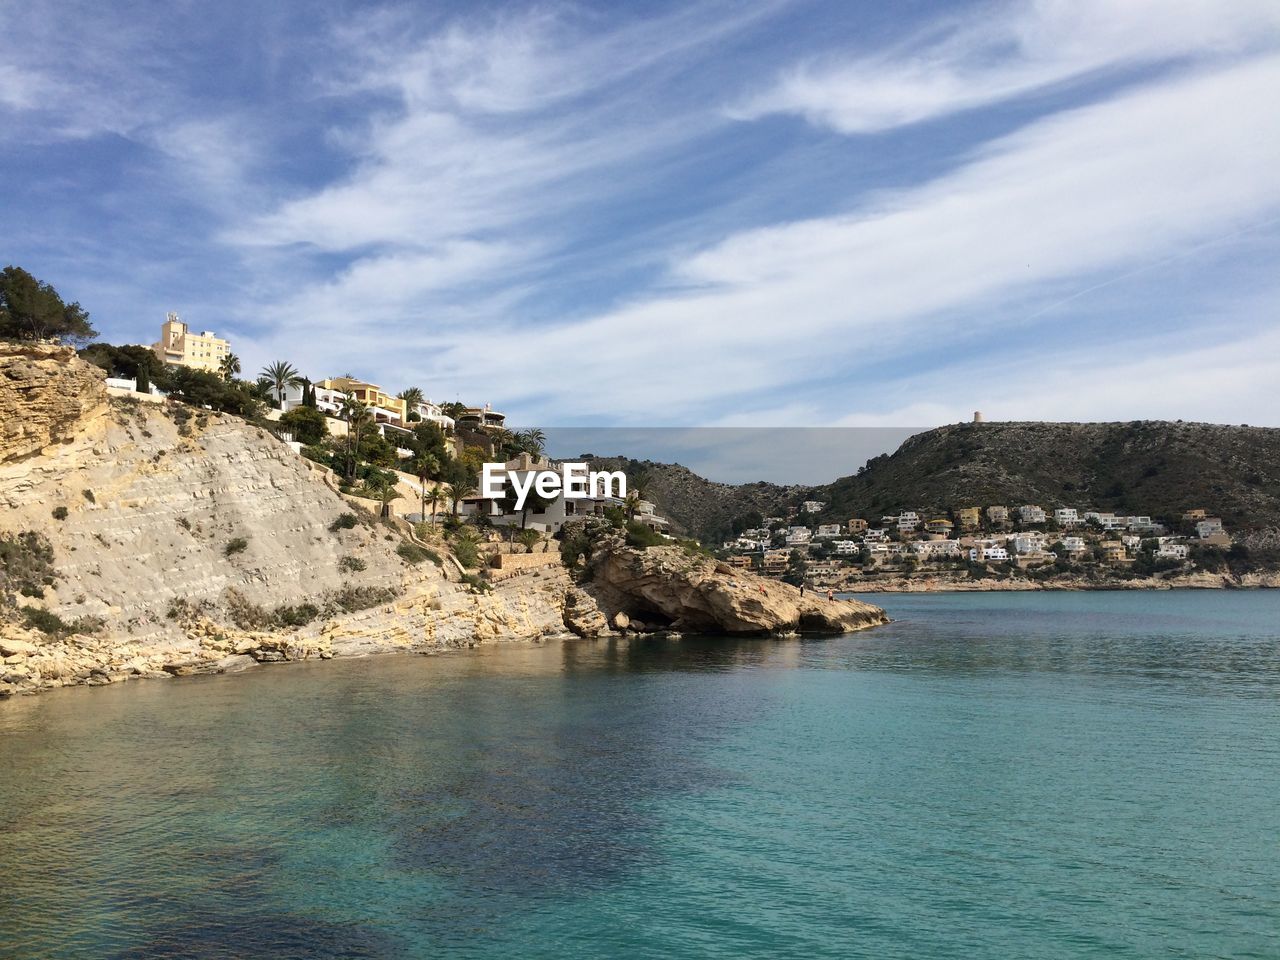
[0,591,1280,960]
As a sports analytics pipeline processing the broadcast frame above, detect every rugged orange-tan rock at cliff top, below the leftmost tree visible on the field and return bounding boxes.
[0,343,106,462]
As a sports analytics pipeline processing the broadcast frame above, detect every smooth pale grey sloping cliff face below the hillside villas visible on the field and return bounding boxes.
[0,399,406,639]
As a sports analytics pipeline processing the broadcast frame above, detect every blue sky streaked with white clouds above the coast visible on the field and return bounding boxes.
[0,0,1280,440]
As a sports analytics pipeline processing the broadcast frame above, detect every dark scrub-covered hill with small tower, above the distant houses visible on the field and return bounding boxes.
[812,420,1280,530]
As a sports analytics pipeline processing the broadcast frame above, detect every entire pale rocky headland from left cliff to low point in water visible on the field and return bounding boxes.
[0,344,883,696]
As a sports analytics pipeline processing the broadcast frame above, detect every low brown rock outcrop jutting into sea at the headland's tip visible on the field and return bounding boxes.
[591,545,888,635]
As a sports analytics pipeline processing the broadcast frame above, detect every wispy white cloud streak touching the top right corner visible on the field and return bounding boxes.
[731,0,1280,133]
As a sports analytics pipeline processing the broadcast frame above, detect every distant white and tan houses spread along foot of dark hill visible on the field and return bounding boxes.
[724,500,1231,582]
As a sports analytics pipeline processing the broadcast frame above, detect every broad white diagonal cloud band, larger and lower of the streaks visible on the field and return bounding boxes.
[453,58,1280,422]
